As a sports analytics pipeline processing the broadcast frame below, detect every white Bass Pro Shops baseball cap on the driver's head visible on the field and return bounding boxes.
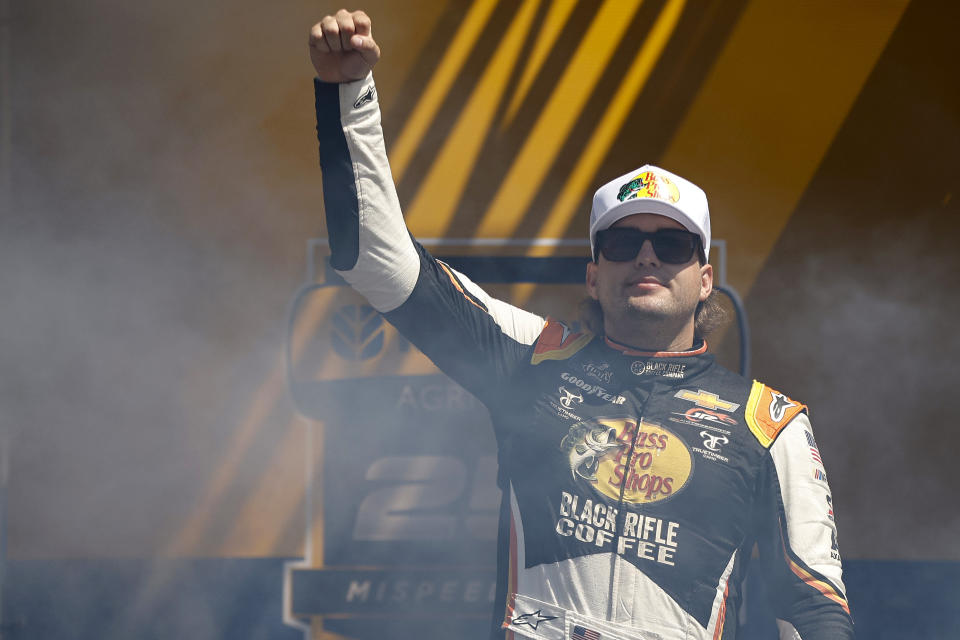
[590,164,710,260]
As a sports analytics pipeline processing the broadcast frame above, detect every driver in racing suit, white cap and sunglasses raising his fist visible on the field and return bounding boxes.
[310,10,853,640]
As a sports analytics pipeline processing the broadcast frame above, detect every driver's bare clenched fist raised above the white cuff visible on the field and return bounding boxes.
[310,9,380,82]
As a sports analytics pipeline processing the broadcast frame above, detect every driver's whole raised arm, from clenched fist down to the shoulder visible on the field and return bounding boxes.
[310,10,544,393]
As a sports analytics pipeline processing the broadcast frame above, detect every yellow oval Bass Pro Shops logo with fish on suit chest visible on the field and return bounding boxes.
[560,418,693,504]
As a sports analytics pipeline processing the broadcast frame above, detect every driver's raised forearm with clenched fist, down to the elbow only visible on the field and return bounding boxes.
[310,10,419,312]
